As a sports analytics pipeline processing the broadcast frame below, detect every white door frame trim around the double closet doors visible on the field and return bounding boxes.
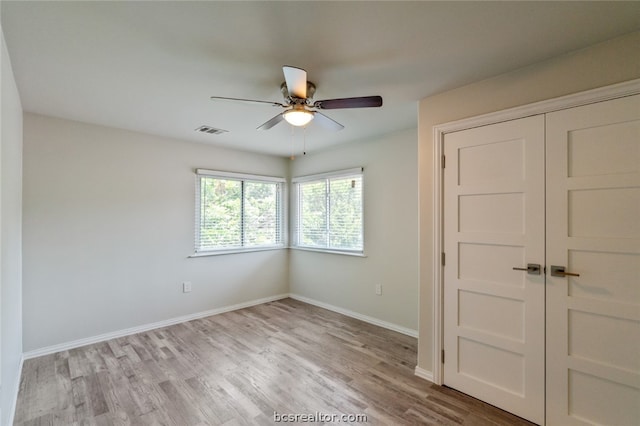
[430,79,640,385]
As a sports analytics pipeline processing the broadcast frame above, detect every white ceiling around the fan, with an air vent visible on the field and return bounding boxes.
[1,0,640,156]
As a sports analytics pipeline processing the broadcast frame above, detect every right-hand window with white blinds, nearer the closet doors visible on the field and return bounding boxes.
[293,168,363,254]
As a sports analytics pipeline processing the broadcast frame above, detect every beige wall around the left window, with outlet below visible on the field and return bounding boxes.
[21,113,289,351]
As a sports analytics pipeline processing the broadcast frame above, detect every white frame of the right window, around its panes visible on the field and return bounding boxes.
[290,167,366,257]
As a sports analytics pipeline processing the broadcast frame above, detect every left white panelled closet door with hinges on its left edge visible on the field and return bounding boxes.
[444,116,545,424]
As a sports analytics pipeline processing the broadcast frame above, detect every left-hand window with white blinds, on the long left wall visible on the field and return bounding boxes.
[195,169,285,254]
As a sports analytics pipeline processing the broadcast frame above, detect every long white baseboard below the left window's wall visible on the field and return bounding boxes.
[23,294,289,359]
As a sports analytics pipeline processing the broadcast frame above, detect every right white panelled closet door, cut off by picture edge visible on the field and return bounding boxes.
[546,96,640,425]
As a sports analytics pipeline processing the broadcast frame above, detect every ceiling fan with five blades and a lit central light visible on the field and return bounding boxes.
[211,66,382,130]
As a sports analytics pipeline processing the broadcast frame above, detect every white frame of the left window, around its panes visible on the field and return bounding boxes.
[189,169,288,257]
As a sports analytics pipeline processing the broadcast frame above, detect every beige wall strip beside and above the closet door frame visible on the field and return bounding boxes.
[418,32,640,371]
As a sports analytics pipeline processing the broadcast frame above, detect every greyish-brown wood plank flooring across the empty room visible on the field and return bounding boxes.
[14,299,530,426]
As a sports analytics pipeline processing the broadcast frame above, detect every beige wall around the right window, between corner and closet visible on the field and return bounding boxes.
[289,128,418,334]
